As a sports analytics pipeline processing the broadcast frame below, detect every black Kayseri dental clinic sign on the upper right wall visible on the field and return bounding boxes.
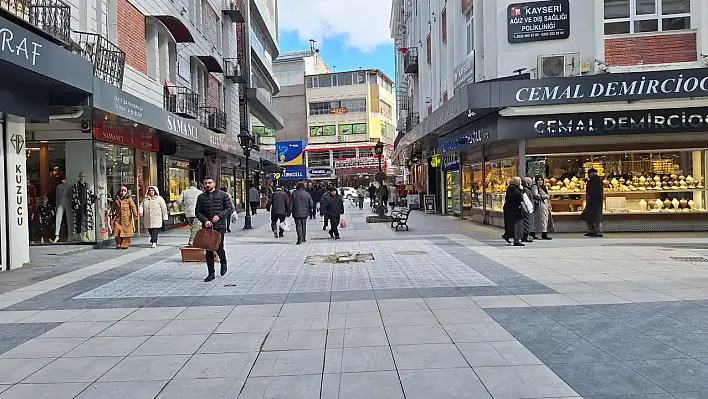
[507,0,570,43]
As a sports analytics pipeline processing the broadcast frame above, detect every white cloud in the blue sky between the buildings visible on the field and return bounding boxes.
[278,0,391,52]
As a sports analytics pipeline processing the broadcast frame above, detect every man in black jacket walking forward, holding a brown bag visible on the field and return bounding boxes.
[195,177,233,282]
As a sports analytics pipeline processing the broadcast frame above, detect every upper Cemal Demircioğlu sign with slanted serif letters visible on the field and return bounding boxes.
[499,68,708,106]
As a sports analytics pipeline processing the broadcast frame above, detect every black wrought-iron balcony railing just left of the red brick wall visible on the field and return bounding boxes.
[74,32,125,87]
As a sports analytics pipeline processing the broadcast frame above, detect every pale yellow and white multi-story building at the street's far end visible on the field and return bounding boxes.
[305,69,395,186]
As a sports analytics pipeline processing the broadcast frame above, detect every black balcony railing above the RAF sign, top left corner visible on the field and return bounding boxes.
[0,0,71,44]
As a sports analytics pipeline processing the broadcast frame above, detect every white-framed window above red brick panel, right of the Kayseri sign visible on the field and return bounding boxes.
[605,0,691,35]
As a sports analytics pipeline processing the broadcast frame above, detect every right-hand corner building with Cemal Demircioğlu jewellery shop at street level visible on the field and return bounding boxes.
[391,0,708,231]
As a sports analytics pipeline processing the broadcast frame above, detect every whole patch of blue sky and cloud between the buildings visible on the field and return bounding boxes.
[278,0,395,80]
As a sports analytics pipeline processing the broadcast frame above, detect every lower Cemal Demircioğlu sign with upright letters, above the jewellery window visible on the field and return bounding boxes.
[499,108,708,139]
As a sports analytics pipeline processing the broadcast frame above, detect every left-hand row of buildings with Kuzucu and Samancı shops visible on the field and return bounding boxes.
[0,0,282,268]
